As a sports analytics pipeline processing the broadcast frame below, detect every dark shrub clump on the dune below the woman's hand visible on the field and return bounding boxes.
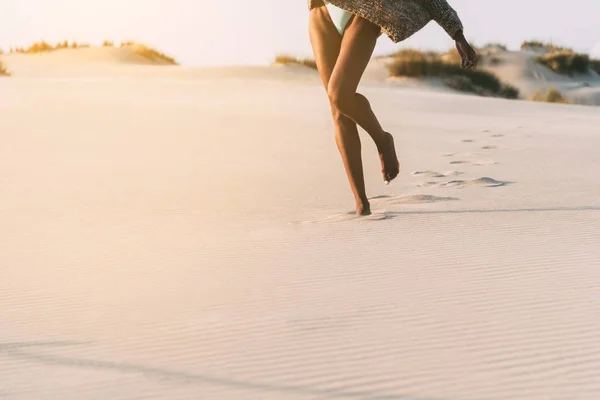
[388,50,519,99]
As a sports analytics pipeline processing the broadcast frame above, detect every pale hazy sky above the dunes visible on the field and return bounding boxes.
[0,0,600,65]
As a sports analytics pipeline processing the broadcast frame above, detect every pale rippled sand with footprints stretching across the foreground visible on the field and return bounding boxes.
[0,50,600,400]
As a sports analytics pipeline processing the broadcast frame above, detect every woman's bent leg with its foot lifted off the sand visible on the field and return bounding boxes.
[327,17,399,181]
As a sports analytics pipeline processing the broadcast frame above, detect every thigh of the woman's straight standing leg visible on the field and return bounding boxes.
[309,5,342,89]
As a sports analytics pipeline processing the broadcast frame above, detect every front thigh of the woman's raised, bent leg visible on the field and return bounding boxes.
[328,17,381,95]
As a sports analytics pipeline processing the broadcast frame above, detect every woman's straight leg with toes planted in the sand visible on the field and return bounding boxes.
[309,6,371,215]
